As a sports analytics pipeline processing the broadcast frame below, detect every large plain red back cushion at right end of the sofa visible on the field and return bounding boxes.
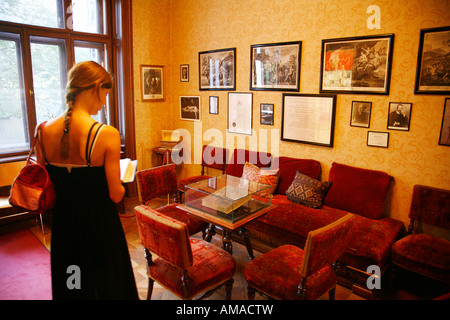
[324,163,392,219]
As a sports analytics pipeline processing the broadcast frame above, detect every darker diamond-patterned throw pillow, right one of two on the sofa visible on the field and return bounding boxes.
[286,171,331,208]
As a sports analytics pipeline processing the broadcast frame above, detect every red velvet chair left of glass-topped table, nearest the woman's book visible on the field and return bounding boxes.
[136,163,208,235]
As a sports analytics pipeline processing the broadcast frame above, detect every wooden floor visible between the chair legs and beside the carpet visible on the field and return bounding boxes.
[4,198,448,300]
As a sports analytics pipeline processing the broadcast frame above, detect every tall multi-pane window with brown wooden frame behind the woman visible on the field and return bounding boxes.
[0,0,131,160]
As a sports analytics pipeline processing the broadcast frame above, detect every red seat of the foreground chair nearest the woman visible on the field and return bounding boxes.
[148,239,236,299]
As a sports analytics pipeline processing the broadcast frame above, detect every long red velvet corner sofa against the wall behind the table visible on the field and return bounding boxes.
[227,157,404,286]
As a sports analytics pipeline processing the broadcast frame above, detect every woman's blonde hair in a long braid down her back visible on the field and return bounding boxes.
[60,61,113,159]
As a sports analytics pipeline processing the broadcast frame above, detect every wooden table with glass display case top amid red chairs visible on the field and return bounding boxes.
[178,174,273,259]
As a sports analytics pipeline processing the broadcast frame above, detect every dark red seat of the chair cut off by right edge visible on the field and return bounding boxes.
[392,234,450,283]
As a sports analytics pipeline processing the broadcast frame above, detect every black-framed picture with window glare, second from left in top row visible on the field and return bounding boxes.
[250,41,302,91]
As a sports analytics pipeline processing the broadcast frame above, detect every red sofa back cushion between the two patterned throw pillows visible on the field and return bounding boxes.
[272,157,321,195]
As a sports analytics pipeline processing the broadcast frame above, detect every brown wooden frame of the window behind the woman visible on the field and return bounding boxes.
[0,0,136,163]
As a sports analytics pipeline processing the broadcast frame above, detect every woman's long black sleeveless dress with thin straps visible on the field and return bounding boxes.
[46,124,138,300]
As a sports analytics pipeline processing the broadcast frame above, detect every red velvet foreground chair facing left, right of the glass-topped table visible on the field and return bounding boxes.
[244,213,354,300]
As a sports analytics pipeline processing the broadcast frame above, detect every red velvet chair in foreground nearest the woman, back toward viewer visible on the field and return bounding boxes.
[135,205,236,300]
